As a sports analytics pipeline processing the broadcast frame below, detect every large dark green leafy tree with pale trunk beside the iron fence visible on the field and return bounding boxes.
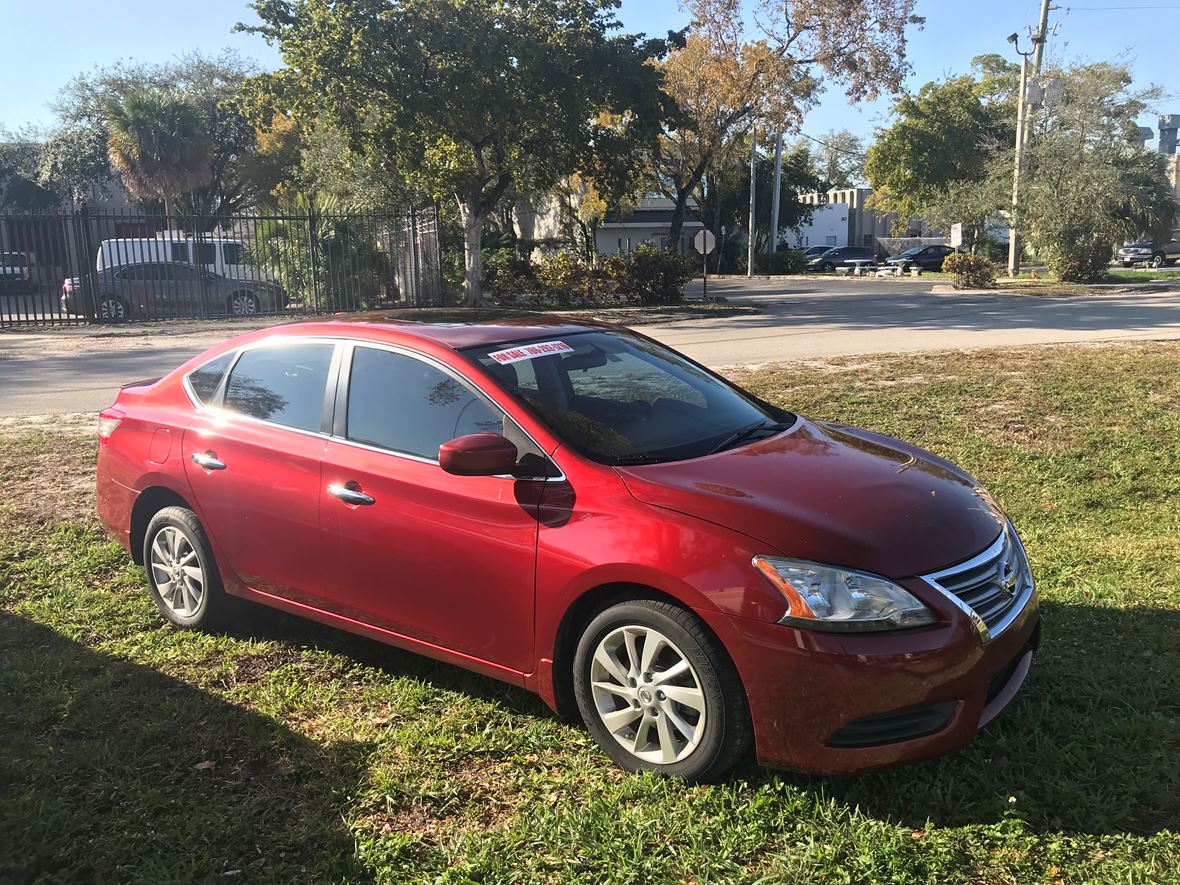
[250,0,663,303]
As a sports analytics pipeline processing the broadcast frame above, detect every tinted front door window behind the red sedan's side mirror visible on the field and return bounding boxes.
[347,347,502,459]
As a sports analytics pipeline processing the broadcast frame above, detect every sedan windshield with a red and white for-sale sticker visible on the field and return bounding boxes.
[464,332,794,465]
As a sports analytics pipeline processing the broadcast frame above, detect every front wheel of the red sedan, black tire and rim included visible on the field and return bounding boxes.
[573,599,752,780]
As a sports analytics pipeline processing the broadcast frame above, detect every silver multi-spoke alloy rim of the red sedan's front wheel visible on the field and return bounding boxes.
[590,624,707,765]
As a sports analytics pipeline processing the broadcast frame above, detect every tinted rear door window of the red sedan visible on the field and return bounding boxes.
[225,343,333,431]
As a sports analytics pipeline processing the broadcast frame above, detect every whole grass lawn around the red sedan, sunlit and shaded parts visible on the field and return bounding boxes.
[0,343,1180,885]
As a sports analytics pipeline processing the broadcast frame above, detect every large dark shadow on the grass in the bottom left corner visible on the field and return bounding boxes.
[0,612,375,883]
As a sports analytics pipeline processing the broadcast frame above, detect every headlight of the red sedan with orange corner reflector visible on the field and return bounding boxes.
[753,556,937,632]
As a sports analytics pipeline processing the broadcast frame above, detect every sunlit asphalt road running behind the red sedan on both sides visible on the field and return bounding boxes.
[0,280,1180,418]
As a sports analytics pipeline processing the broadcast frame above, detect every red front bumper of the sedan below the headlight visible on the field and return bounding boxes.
[715,582,1040,774]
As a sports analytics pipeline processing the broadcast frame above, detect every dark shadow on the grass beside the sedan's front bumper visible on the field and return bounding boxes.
[742,601,1180,834]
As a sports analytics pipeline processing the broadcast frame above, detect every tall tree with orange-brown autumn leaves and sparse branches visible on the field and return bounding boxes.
[654,0,922,241]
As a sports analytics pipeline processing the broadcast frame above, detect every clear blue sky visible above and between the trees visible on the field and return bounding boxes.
[0,0,1180,145]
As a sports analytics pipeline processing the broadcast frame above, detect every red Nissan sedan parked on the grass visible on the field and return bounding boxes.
[98,315,1038,779]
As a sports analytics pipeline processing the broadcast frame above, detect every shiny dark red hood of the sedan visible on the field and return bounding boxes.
[617,418,1005,578]
